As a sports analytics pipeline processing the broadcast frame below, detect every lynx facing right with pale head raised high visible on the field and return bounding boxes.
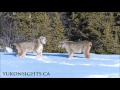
[14,36,46,57]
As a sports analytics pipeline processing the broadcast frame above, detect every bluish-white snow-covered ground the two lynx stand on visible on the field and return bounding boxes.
[0,52,120,78]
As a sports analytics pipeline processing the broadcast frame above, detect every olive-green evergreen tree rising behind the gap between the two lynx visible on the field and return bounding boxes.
[45,12,65,52]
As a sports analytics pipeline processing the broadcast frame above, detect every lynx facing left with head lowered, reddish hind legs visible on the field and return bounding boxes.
[58,39,92,58]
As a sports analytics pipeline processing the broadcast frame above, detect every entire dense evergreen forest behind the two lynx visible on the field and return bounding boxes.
[0,12,120,54]
